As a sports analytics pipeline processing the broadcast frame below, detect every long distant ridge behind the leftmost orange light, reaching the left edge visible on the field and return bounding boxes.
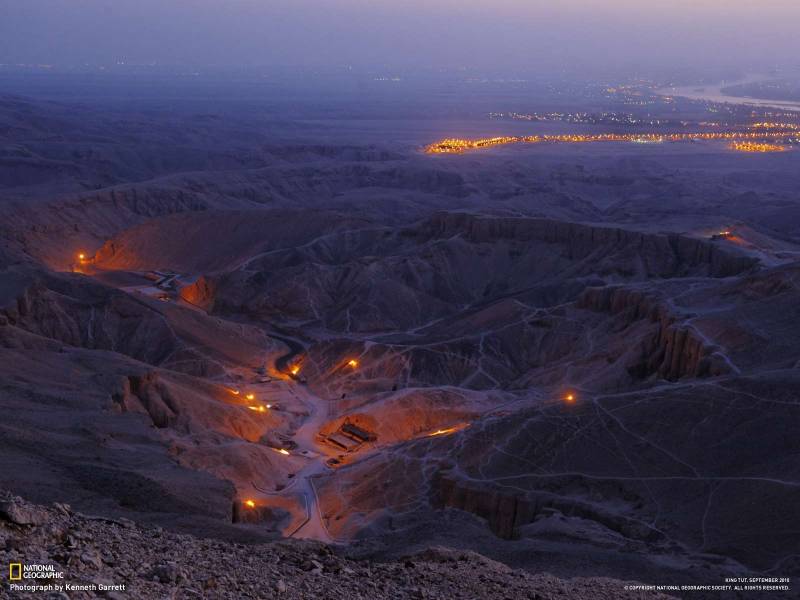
[0,162,470,269]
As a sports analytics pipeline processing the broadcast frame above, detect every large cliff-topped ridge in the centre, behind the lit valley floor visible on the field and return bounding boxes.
[186,213,758,333]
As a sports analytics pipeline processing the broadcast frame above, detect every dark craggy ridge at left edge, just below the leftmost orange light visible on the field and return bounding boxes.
[0,268,271,377]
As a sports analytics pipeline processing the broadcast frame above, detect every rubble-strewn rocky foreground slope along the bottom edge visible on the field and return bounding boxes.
[0,492,669,600]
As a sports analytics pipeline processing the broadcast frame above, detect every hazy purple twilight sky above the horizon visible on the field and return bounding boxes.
[0,0,800,69]
